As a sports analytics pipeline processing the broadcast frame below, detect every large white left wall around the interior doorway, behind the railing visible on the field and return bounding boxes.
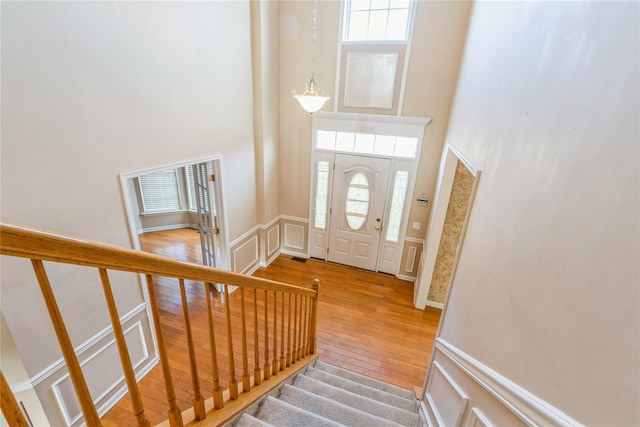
[1,1,256,424]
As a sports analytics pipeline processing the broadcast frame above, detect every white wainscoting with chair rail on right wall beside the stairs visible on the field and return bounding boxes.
[423,338,581,427]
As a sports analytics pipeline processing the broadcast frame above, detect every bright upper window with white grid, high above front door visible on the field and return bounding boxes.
[343,0,411,41]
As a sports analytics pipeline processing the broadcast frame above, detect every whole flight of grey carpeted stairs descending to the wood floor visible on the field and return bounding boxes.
[231,360,422,427]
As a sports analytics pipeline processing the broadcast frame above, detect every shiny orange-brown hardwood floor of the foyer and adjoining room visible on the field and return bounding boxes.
[102,229,440,426]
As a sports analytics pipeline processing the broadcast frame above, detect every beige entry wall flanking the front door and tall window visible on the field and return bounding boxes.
[280,0,471,244]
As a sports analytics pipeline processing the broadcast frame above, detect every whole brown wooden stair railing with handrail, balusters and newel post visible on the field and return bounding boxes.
[0,224,320,427]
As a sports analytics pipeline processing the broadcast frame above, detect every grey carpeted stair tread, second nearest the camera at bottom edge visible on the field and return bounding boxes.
[256,396,341,427]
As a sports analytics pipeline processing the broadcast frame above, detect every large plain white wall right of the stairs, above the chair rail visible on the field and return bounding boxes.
[431,2,640,426]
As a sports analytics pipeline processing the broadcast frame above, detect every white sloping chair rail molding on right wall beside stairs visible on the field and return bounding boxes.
[434,338,582,426]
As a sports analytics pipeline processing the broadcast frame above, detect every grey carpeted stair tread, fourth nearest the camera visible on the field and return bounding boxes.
[293,374,420,426]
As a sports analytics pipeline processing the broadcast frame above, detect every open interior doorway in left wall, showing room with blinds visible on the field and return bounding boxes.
[120,157,229,269]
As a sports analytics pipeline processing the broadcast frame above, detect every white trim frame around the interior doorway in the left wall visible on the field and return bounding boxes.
[119,154,230,270]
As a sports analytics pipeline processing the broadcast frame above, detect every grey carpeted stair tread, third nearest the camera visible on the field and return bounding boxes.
[279,384,401,427]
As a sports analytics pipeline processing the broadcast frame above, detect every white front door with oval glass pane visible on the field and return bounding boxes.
[327,154,391,270]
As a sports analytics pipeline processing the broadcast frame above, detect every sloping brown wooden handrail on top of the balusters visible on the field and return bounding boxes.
[0,223,315,297]
